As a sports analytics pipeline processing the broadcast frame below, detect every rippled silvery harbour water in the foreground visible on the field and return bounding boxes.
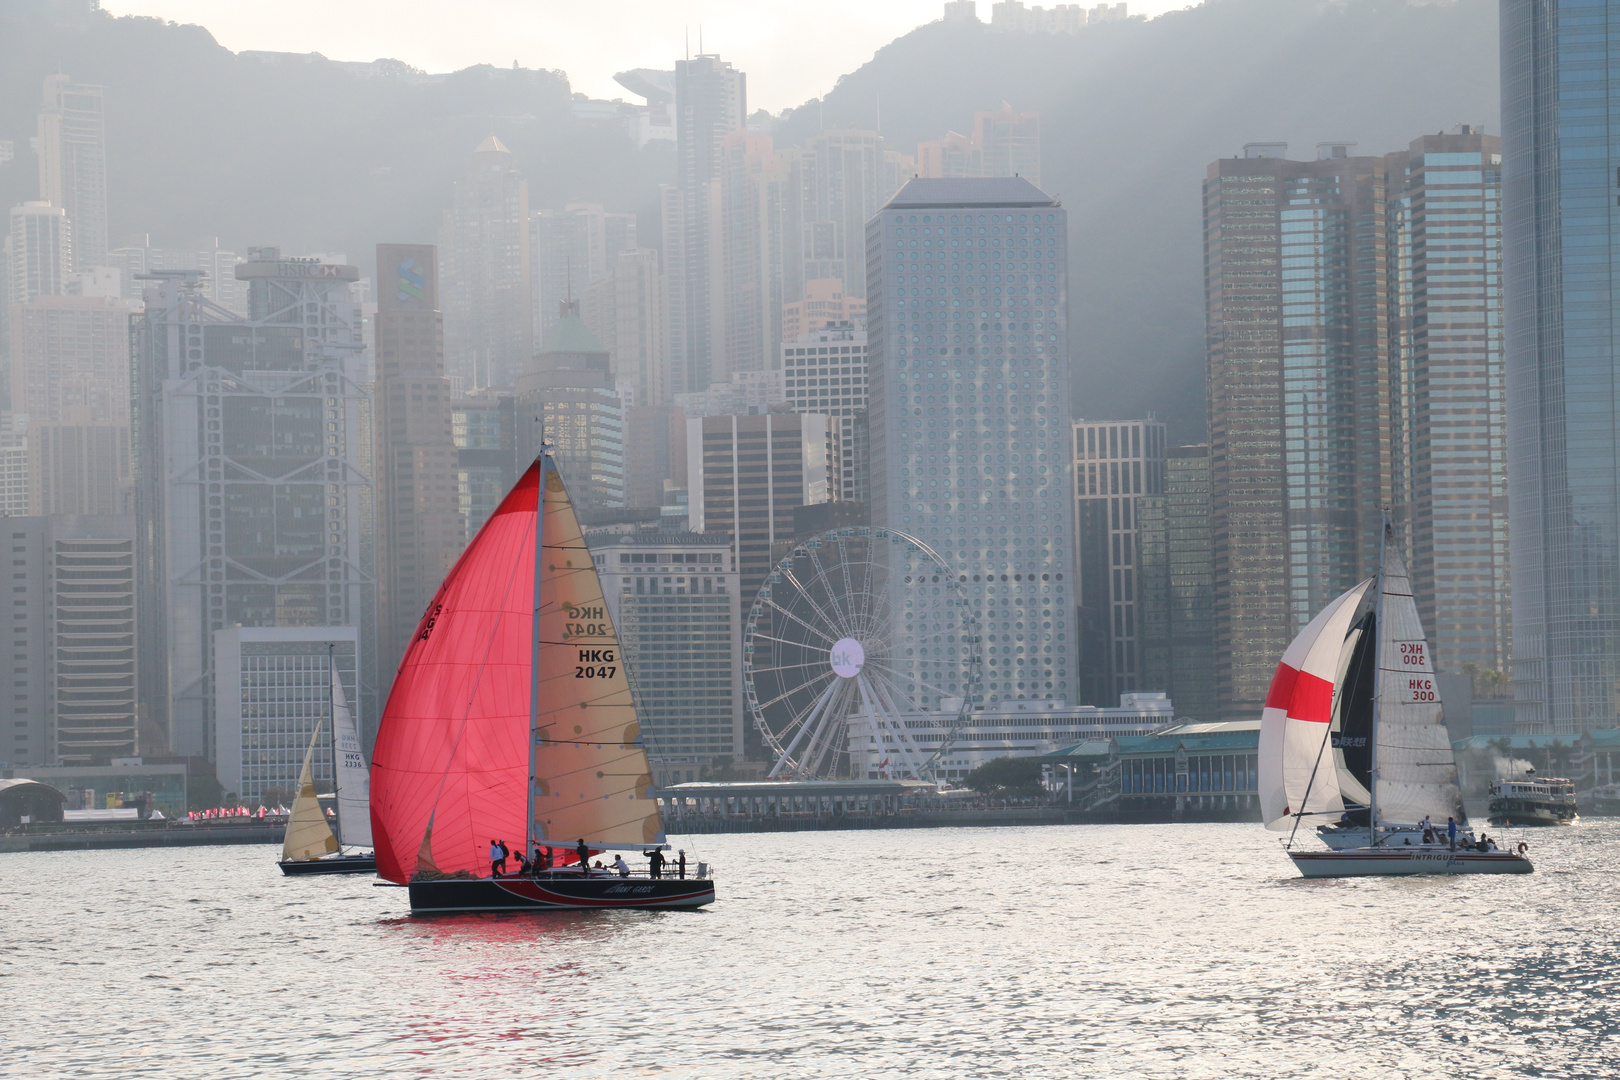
[0,823,1620,1080]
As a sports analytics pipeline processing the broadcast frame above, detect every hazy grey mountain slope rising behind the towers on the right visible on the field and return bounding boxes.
[779,0,1500,440]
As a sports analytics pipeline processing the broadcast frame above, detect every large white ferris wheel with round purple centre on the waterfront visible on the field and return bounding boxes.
[742,526,982,780]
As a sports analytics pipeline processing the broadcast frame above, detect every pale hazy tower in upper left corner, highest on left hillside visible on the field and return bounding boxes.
[37,74,107,270]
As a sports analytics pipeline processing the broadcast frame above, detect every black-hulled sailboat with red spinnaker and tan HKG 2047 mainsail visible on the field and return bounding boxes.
[371,449,714,913]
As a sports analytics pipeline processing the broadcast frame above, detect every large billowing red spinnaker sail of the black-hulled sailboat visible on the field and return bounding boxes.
[371,463,539,882]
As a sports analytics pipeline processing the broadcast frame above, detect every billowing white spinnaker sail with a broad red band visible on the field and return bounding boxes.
[1259,580,1372,832]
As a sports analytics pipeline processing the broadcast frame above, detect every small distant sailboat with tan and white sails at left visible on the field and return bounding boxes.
[277,644,377,876]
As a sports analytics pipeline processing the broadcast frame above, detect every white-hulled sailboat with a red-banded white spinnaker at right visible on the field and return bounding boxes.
[1259,520,1533,878]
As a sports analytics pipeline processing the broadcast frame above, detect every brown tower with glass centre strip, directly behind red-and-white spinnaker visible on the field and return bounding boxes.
[1204,142,1390,719]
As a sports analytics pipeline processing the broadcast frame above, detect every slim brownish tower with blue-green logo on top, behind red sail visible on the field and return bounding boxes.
[374,244,465,677]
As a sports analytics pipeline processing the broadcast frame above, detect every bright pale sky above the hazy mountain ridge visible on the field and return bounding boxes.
[102,0,1189,112]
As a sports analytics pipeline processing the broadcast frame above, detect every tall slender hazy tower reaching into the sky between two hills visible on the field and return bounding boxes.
[663,55,748,393]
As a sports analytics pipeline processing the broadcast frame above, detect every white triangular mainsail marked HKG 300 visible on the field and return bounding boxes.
[1372,526,1466,826]
